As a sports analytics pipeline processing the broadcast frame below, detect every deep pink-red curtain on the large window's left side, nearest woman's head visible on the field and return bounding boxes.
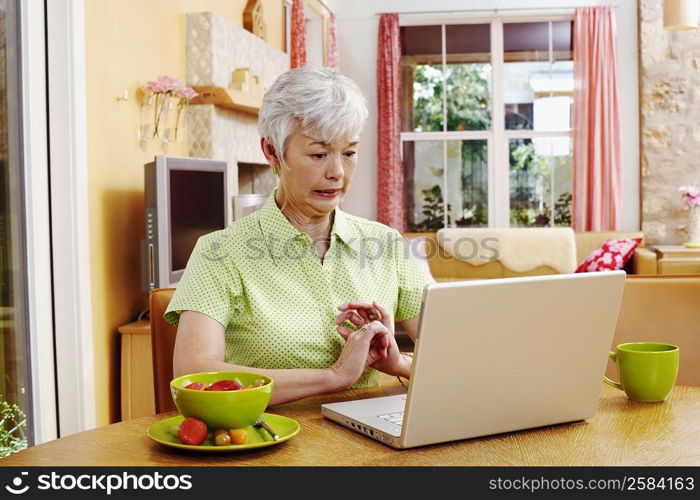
[377,14,406,231]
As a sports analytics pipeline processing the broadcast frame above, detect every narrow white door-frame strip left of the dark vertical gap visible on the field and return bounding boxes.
[13,0,58,446]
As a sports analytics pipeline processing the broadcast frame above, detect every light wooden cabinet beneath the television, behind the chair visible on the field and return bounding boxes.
[118,320,156,420]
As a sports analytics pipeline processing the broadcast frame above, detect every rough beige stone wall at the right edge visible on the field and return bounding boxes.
[639,0,700,244]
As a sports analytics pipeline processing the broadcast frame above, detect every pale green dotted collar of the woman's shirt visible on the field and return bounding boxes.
[260,188,361,255]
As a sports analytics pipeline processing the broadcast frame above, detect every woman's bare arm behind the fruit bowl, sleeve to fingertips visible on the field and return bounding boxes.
[173,311,389,405]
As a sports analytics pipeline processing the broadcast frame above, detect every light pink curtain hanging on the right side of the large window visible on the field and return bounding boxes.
[572,6,622,231]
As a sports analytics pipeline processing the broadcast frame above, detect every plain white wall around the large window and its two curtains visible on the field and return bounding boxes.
[326,0,640,230]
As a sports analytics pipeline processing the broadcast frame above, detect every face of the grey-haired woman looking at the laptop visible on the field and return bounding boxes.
[268,129,358,216]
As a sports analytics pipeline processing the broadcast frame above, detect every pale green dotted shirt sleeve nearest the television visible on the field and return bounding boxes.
[163,234,243,328]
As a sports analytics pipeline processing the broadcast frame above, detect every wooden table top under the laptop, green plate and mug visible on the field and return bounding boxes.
[0,385,700,466]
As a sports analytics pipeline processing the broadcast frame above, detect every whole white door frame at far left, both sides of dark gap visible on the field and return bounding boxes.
[8,0,96,445]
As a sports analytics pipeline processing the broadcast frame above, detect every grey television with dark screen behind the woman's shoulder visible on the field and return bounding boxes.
[142,156,229,291]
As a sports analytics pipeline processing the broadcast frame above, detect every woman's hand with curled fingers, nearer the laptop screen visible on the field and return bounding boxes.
[335,301,411,378]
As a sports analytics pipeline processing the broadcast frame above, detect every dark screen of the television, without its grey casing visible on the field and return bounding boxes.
[170,169,226,272]
